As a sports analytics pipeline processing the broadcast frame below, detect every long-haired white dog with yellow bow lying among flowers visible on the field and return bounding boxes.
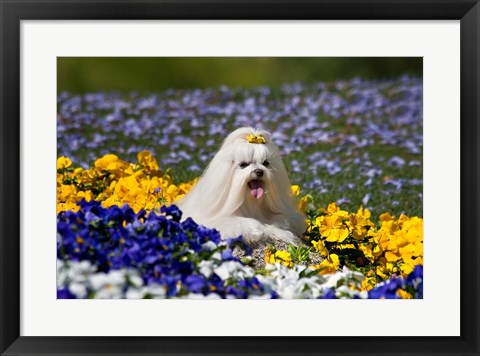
[179,127,306,244]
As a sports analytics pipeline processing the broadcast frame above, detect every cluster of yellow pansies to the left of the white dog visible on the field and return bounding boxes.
[57,151,201,212]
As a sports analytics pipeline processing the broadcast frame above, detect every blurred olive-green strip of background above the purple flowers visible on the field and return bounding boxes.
[57,57,423,94]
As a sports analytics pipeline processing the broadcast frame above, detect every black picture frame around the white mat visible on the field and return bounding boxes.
[0,0,480,355]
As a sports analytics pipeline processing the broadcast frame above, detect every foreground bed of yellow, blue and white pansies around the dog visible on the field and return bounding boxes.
[57,152,423,298]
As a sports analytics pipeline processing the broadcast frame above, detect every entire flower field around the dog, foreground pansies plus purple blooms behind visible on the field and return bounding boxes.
[57,76,423,298]
